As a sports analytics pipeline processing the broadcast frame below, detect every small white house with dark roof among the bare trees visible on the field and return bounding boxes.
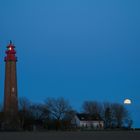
[72,113,104,129]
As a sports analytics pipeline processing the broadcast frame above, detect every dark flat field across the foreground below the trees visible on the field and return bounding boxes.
[0,131,140,140]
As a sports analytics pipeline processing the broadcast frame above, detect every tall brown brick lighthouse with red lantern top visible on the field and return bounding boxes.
[4,41,18,124]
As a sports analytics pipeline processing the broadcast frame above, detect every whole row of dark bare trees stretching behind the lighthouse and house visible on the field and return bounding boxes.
[0,97,132,130]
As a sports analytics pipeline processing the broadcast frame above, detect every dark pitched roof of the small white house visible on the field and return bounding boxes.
[76,113,102,121]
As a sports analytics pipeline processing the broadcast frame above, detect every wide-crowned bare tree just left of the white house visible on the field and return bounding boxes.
[45,98,72,130]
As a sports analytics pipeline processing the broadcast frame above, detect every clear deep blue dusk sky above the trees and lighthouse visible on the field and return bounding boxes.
[0,0,140,127]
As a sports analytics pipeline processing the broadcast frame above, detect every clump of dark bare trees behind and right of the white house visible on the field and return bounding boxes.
[82,101,131,128]
